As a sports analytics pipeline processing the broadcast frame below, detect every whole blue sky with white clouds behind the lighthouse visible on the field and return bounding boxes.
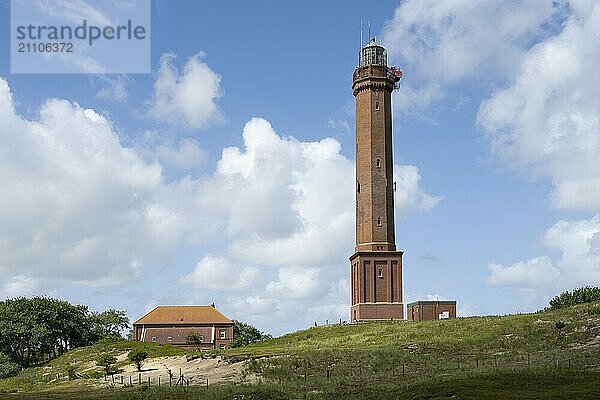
[0,0,600,334]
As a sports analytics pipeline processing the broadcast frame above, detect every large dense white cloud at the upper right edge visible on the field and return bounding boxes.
[478,3,600,212]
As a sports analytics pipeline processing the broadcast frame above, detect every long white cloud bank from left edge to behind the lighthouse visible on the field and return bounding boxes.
[0,79,437,332]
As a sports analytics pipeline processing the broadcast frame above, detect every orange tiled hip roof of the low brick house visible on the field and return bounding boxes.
[134,306,232,325]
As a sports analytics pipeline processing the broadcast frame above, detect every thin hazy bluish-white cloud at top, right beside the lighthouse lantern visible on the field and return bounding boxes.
[383,0,563,112]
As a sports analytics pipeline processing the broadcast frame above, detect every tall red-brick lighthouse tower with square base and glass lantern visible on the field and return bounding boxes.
[350,38,404,321]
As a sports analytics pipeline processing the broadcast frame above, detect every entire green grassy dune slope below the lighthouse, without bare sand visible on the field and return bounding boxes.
[0,302,600,399]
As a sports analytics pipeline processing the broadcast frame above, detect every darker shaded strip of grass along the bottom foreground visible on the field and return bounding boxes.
[4,369,600,400]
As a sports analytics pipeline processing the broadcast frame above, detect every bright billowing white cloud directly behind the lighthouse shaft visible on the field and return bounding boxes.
[175,118,439,332]
